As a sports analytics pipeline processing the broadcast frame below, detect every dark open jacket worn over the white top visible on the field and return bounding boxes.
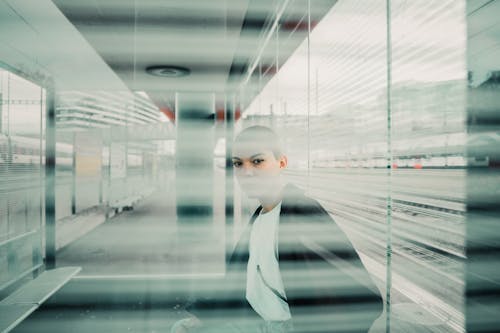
[191,185,383,332]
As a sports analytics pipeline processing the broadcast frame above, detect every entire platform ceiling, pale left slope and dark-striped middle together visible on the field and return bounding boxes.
[0,0,336,107]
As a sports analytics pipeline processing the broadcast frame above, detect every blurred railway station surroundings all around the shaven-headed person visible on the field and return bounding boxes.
[0,0,500,332]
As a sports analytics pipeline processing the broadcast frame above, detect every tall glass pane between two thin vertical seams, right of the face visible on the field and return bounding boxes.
[309,1,388,330]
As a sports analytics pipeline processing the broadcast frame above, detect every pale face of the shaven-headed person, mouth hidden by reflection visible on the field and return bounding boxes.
[229,143,287,199]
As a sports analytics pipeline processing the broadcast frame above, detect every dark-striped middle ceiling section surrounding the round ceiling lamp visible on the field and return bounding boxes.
[49,0,336,105]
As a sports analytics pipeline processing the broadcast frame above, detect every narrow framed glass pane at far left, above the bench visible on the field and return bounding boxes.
[0,68,45,290]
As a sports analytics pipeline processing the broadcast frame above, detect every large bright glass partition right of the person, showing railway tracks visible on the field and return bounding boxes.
[239,1,467,332]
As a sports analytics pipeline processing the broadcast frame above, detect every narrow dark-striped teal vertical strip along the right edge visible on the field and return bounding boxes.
[465,1,500,332]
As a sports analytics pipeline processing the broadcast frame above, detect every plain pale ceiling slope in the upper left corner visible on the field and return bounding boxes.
[0,0,128,91]
